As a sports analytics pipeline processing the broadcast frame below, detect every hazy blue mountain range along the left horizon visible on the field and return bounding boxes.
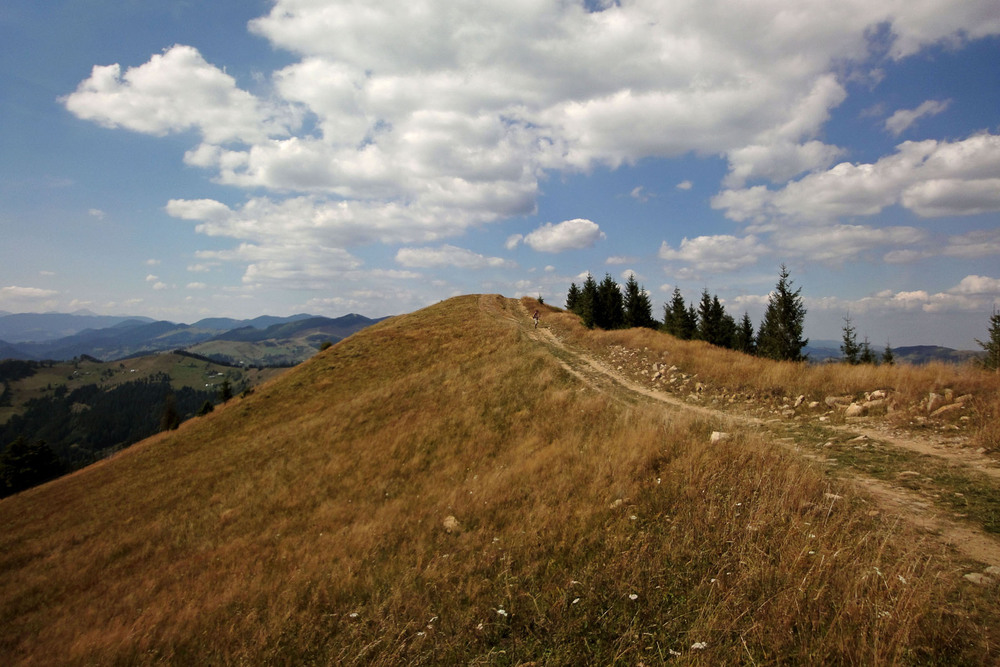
[0,313,384,365]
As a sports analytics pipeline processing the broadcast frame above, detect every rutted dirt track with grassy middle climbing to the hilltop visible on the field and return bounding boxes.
[504,300,1000,566]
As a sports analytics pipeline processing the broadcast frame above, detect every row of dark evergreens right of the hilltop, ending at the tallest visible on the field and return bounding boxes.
[566,265,809,361]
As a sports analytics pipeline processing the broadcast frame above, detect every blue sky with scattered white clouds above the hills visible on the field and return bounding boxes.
[0,0,1000,349]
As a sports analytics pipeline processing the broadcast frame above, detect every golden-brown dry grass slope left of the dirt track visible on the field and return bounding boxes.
[0,296,989,665]
